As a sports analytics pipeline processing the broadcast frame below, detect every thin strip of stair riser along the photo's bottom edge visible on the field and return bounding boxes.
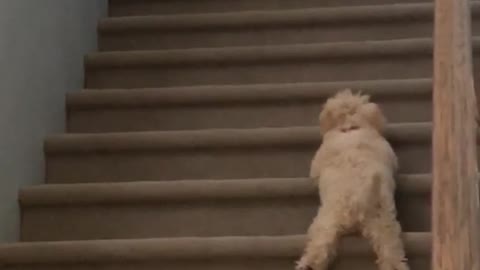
[4,254,430,270]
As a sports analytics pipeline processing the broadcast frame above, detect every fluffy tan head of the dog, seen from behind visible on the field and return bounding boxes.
[319,89,386,134]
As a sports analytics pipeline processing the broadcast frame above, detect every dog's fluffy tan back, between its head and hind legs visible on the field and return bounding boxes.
[311,126,396,219]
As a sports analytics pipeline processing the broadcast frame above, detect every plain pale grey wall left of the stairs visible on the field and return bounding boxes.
[0,0,106,242]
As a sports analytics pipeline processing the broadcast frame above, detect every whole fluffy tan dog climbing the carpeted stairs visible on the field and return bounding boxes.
[297,89,409,270]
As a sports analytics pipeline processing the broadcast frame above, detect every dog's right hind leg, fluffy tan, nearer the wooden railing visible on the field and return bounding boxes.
[362,208,409,270]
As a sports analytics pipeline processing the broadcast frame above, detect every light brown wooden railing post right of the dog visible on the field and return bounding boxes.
[432,0,480,270]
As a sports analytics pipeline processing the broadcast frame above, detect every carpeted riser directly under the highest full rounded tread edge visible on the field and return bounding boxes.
[99,20,480,51]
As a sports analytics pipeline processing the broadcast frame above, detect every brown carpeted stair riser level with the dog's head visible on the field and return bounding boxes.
[67,98,432,133]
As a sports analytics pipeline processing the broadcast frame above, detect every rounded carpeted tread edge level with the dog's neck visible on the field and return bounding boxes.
[45,122,431,153]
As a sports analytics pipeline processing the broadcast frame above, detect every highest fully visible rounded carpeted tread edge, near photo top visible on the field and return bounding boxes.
[98,1,462,33]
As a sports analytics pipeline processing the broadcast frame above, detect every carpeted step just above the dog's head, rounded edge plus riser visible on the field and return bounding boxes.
[85,37,480,88]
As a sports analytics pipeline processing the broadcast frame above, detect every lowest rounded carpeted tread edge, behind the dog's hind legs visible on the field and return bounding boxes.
[0,232,431,264]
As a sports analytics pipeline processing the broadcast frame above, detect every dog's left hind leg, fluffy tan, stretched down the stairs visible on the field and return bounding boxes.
[296,211,340,270]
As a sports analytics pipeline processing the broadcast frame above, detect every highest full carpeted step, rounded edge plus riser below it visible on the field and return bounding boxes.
[98,1,480,51]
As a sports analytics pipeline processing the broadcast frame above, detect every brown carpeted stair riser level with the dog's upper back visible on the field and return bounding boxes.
[47,142,431,183]
